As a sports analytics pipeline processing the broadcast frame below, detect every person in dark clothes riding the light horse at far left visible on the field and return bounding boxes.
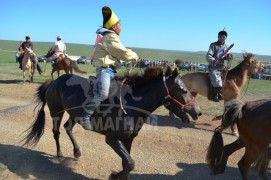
[18,36,42,74]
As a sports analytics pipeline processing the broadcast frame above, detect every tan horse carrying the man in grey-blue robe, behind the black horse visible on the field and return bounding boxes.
[182,53,260,135]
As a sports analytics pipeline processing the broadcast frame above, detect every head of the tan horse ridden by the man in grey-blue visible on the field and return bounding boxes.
[243,53,262,75]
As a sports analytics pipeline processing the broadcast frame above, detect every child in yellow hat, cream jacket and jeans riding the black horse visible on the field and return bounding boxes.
[80,6,139,130]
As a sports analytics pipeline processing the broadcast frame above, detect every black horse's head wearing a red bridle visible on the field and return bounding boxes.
[163,68,201,120]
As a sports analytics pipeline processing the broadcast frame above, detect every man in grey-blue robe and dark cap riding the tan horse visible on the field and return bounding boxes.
[206,30,232,102]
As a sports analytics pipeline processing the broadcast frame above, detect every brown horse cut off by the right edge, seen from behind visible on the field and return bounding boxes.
[206,99,271,180]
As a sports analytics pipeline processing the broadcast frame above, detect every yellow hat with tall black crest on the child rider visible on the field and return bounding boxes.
[102,6,119,29]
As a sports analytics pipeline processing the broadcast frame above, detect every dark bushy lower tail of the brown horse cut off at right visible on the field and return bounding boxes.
[206,126,224,174]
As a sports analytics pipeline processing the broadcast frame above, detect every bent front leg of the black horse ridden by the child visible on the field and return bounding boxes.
[105,133,135,180]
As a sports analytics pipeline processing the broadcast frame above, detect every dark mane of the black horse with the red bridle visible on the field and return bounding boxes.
[114,67,172,88]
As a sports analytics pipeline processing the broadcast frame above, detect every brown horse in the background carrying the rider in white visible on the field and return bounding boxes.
[45,49,86,79]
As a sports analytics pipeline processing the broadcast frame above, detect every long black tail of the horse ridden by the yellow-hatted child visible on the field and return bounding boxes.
[21,79,53,146]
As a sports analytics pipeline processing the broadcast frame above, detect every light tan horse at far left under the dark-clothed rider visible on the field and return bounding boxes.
[22,47,36,82]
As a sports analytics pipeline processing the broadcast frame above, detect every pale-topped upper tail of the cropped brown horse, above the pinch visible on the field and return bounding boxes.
[221,99,245,127]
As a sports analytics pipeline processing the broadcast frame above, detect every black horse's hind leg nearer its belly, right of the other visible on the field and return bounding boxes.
[64,117,81,158]
